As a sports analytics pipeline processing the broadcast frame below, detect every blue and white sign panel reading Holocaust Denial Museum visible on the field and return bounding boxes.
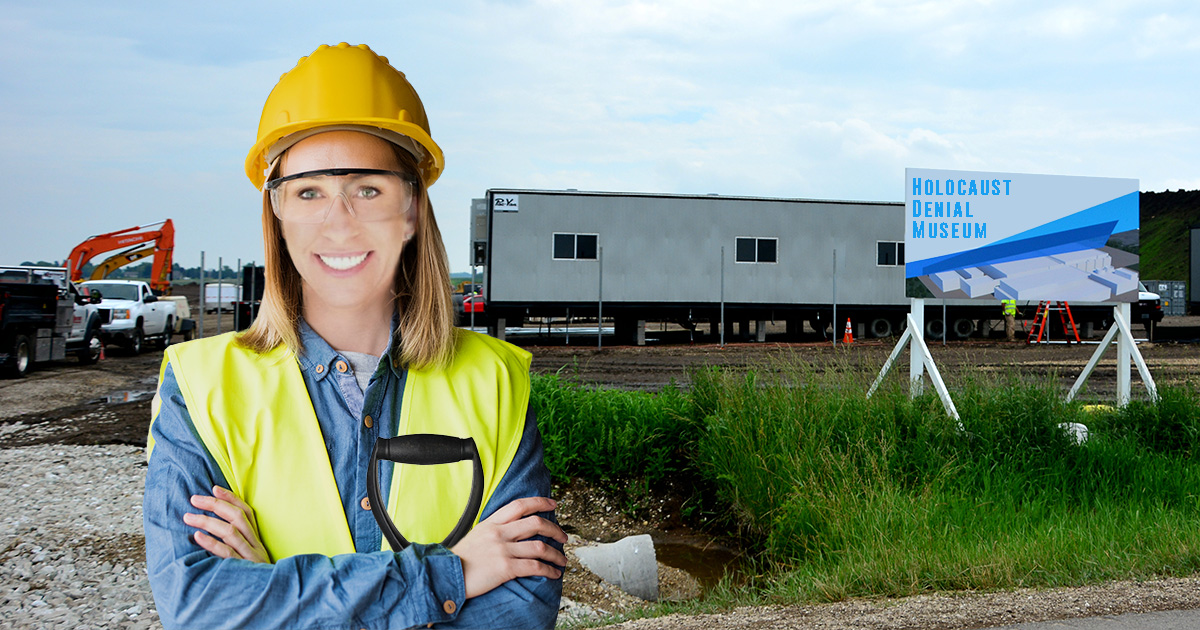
[905,168,1139,302]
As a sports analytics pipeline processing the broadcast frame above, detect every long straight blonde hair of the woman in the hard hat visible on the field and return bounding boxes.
[238,145,455,368]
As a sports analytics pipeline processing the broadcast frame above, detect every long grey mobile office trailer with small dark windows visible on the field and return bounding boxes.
[472,188,907,342]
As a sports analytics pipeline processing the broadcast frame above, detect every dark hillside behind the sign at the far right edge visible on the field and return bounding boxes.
[1139,191,1200,281]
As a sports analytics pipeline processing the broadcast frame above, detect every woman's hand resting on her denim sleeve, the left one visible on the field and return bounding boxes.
[184,486,271,563]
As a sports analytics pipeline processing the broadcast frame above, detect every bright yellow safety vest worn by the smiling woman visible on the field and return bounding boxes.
[146,330,530,560]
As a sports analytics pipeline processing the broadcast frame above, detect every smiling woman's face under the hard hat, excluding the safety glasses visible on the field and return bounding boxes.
[280,131,416,319]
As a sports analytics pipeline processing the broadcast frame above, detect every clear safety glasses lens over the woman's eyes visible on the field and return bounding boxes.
[266,168,413,223]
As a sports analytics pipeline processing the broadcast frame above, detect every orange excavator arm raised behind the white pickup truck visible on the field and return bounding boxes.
[66,218,175,294]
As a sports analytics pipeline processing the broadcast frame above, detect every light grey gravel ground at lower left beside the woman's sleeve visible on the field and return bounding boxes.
[0,445,160,629]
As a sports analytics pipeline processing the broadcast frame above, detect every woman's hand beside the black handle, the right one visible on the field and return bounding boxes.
[450,497,566,599]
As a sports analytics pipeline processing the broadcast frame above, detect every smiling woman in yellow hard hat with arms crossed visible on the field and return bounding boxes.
[144,43,565,628]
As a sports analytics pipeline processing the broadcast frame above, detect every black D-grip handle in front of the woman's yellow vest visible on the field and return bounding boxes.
[367,433,484,551]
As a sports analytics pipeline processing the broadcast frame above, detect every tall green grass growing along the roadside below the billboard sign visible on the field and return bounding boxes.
[534,366,1200,612]
